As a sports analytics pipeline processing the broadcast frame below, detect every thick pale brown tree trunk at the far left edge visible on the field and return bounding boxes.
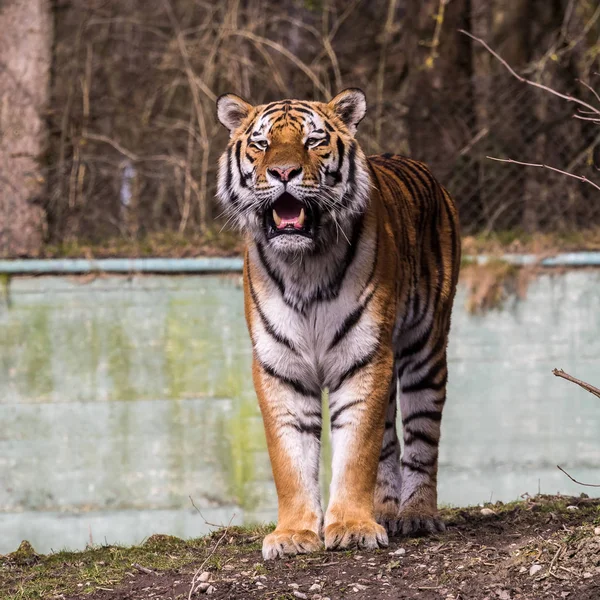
[0,0,53,256]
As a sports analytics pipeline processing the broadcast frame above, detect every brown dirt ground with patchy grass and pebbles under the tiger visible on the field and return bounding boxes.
[0,496,600,600]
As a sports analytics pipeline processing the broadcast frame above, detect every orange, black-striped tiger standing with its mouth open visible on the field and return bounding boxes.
[217,88,460,560]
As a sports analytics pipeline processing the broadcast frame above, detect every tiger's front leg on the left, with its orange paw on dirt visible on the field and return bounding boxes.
[253,359,323,560]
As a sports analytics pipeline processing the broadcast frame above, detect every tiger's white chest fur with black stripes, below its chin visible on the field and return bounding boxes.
[249,218,379,393]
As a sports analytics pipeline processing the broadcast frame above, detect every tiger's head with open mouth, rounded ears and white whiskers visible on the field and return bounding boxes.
[217,89,369,255]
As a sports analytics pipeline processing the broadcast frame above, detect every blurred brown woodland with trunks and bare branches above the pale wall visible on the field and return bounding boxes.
[0,0,600,256]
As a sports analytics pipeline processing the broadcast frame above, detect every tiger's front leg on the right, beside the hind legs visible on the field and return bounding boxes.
[325,349,393,549]
